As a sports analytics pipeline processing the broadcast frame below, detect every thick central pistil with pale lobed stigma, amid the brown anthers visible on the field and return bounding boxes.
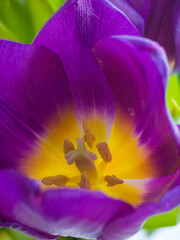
[65,138,97,178]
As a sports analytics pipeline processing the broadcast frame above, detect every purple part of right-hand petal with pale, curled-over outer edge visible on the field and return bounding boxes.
[94,36,180,176]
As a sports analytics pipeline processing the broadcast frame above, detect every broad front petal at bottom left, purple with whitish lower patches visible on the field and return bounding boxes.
[0,170,133,239]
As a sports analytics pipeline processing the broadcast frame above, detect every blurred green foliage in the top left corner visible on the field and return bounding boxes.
[0,0,64,43]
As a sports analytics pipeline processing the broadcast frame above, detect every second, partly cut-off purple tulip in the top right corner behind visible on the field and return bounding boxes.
[109,0,180,71]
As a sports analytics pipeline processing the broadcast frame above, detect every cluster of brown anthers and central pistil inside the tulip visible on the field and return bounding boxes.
[42,121,124,189]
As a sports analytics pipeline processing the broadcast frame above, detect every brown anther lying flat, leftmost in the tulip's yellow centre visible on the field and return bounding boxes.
[41,175,70,186]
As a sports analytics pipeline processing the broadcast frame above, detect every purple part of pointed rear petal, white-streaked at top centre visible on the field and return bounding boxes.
[34,0,137,124]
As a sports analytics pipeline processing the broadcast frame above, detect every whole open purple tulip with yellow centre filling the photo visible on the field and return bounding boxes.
[0,0,180,240]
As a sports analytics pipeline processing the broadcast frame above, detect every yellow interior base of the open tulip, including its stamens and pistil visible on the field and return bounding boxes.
[22,108,154,204]
